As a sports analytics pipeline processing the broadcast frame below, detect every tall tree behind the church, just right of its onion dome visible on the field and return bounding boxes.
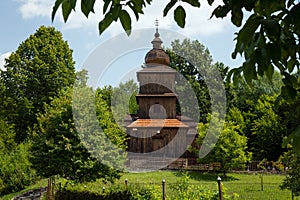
[166,39,228,122]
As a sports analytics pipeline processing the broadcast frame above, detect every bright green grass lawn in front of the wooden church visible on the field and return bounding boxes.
[2,171,300,200]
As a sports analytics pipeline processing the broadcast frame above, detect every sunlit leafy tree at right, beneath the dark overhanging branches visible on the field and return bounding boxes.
[227,73,287,161]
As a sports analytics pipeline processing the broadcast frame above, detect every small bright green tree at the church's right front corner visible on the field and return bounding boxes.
[196,113,251,176]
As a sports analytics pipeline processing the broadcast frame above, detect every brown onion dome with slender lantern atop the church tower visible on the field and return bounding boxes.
[145,29,170,66]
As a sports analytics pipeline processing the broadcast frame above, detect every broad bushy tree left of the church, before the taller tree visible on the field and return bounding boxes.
[31,90,123,181]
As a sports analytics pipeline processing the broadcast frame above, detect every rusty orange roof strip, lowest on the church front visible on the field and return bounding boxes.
[127,119,188,128]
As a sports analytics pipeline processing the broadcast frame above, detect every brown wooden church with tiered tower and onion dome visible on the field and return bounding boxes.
[126,28,196,169]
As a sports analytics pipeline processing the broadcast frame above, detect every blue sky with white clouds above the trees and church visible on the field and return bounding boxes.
[0,0,242,86]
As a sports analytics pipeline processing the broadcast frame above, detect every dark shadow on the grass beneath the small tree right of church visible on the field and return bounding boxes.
[173,170,239,181]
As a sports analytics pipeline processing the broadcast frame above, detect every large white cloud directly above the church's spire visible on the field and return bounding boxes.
[133,0,230,36]
